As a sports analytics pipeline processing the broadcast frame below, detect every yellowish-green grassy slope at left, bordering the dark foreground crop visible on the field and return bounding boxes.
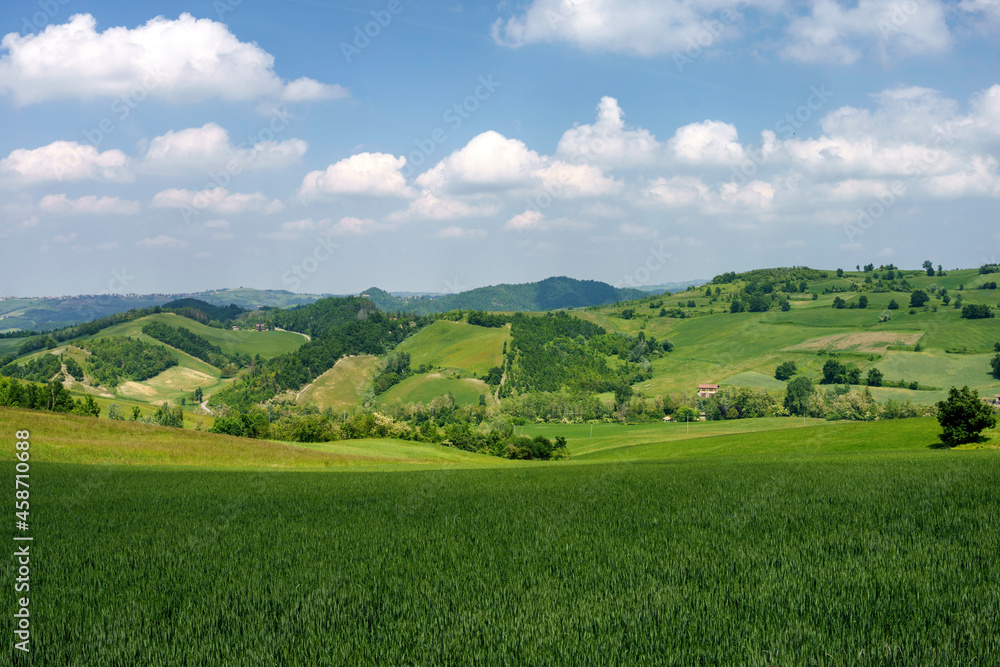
[0,408,505,470]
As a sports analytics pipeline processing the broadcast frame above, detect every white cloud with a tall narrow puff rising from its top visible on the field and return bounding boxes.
[556,97,661,168]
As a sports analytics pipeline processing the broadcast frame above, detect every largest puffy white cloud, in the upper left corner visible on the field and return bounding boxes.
[0,14,346,105]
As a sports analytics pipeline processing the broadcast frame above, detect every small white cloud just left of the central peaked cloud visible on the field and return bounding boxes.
[299,153,413,201]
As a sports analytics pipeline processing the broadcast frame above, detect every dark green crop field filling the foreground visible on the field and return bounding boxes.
[15,450,1000,666]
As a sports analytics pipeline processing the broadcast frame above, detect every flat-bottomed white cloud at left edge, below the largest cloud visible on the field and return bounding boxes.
[0,141,133,183]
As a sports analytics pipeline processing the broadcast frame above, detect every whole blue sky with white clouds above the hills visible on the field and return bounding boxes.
[0,0,1000,296]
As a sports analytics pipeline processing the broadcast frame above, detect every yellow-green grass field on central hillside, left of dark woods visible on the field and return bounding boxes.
[396,320,510,375]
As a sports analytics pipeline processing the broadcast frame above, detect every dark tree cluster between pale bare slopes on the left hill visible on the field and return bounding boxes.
[80,337,177,387]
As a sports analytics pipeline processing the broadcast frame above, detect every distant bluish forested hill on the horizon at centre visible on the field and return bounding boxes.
[364,277,646,315]
